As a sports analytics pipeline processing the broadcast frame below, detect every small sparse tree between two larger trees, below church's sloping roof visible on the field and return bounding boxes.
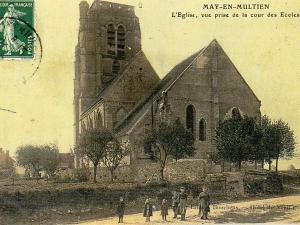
[103,140,129,183]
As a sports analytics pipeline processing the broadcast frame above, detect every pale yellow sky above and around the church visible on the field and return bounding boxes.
[0,0,300,169]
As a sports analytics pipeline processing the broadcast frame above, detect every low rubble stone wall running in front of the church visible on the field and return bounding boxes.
[97,159,245,197]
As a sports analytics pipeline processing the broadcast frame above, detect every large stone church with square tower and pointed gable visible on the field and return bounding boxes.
[74,0,261,176]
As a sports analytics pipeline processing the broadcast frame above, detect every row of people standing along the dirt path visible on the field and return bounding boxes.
[117,188,210,223]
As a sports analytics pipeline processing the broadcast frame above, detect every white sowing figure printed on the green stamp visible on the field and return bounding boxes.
[0,4,25,55]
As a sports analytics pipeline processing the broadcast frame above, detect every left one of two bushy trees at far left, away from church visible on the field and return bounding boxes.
[16,145,42,177]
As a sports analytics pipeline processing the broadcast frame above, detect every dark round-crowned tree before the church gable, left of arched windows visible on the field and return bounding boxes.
[144,119,195,180]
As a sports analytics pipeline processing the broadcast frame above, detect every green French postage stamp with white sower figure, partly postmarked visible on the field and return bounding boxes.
[0,0,35,59]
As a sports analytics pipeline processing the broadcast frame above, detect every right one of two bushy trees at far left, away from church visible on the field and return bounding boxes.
[40,144,60,177]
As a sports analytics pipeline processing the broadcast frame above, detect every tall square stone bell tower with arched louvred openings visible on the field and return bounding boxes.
[74,0,141,142]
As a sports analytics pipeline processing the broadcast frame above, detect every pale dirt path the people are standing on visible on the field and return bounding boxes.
[79,195,300,225]
